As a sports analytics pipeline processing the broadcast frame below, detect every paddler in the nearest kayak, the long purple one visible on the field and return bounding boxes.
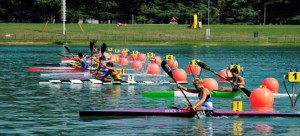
[177,78,213,111]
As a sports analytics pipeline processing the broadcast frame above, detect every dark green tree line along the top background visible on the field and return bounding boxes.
[0,0,300,24]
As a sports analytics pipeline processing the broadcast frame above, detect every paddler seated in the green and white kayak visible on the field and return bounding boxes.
[220,67,245,92]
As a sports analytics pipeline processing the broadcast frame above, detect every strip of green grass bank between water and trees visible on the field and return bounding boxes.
[0,23,300,45]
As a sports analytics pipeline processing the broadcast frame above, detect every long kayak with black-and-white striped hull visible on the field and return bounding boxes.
[39,79,186,85]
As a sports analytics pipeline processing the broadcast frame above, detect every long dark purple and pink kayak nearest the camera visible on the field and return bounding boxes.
[79,108,300,118]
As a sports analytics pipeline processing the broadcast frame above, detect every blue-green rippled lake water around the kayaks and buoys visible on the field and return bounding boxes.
[0,46,300,135]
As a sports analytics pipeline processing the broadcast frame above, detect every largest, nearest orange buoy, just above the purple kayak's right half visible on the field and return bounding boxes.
[250,88,274,107]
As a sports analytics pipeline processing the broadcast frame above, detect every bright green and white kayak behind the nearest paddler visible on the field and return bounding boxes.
[143,90,242,98]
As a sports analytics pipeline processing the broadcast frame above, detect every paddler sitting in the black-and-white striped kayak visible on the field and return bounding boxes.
[101,61,122,82]
